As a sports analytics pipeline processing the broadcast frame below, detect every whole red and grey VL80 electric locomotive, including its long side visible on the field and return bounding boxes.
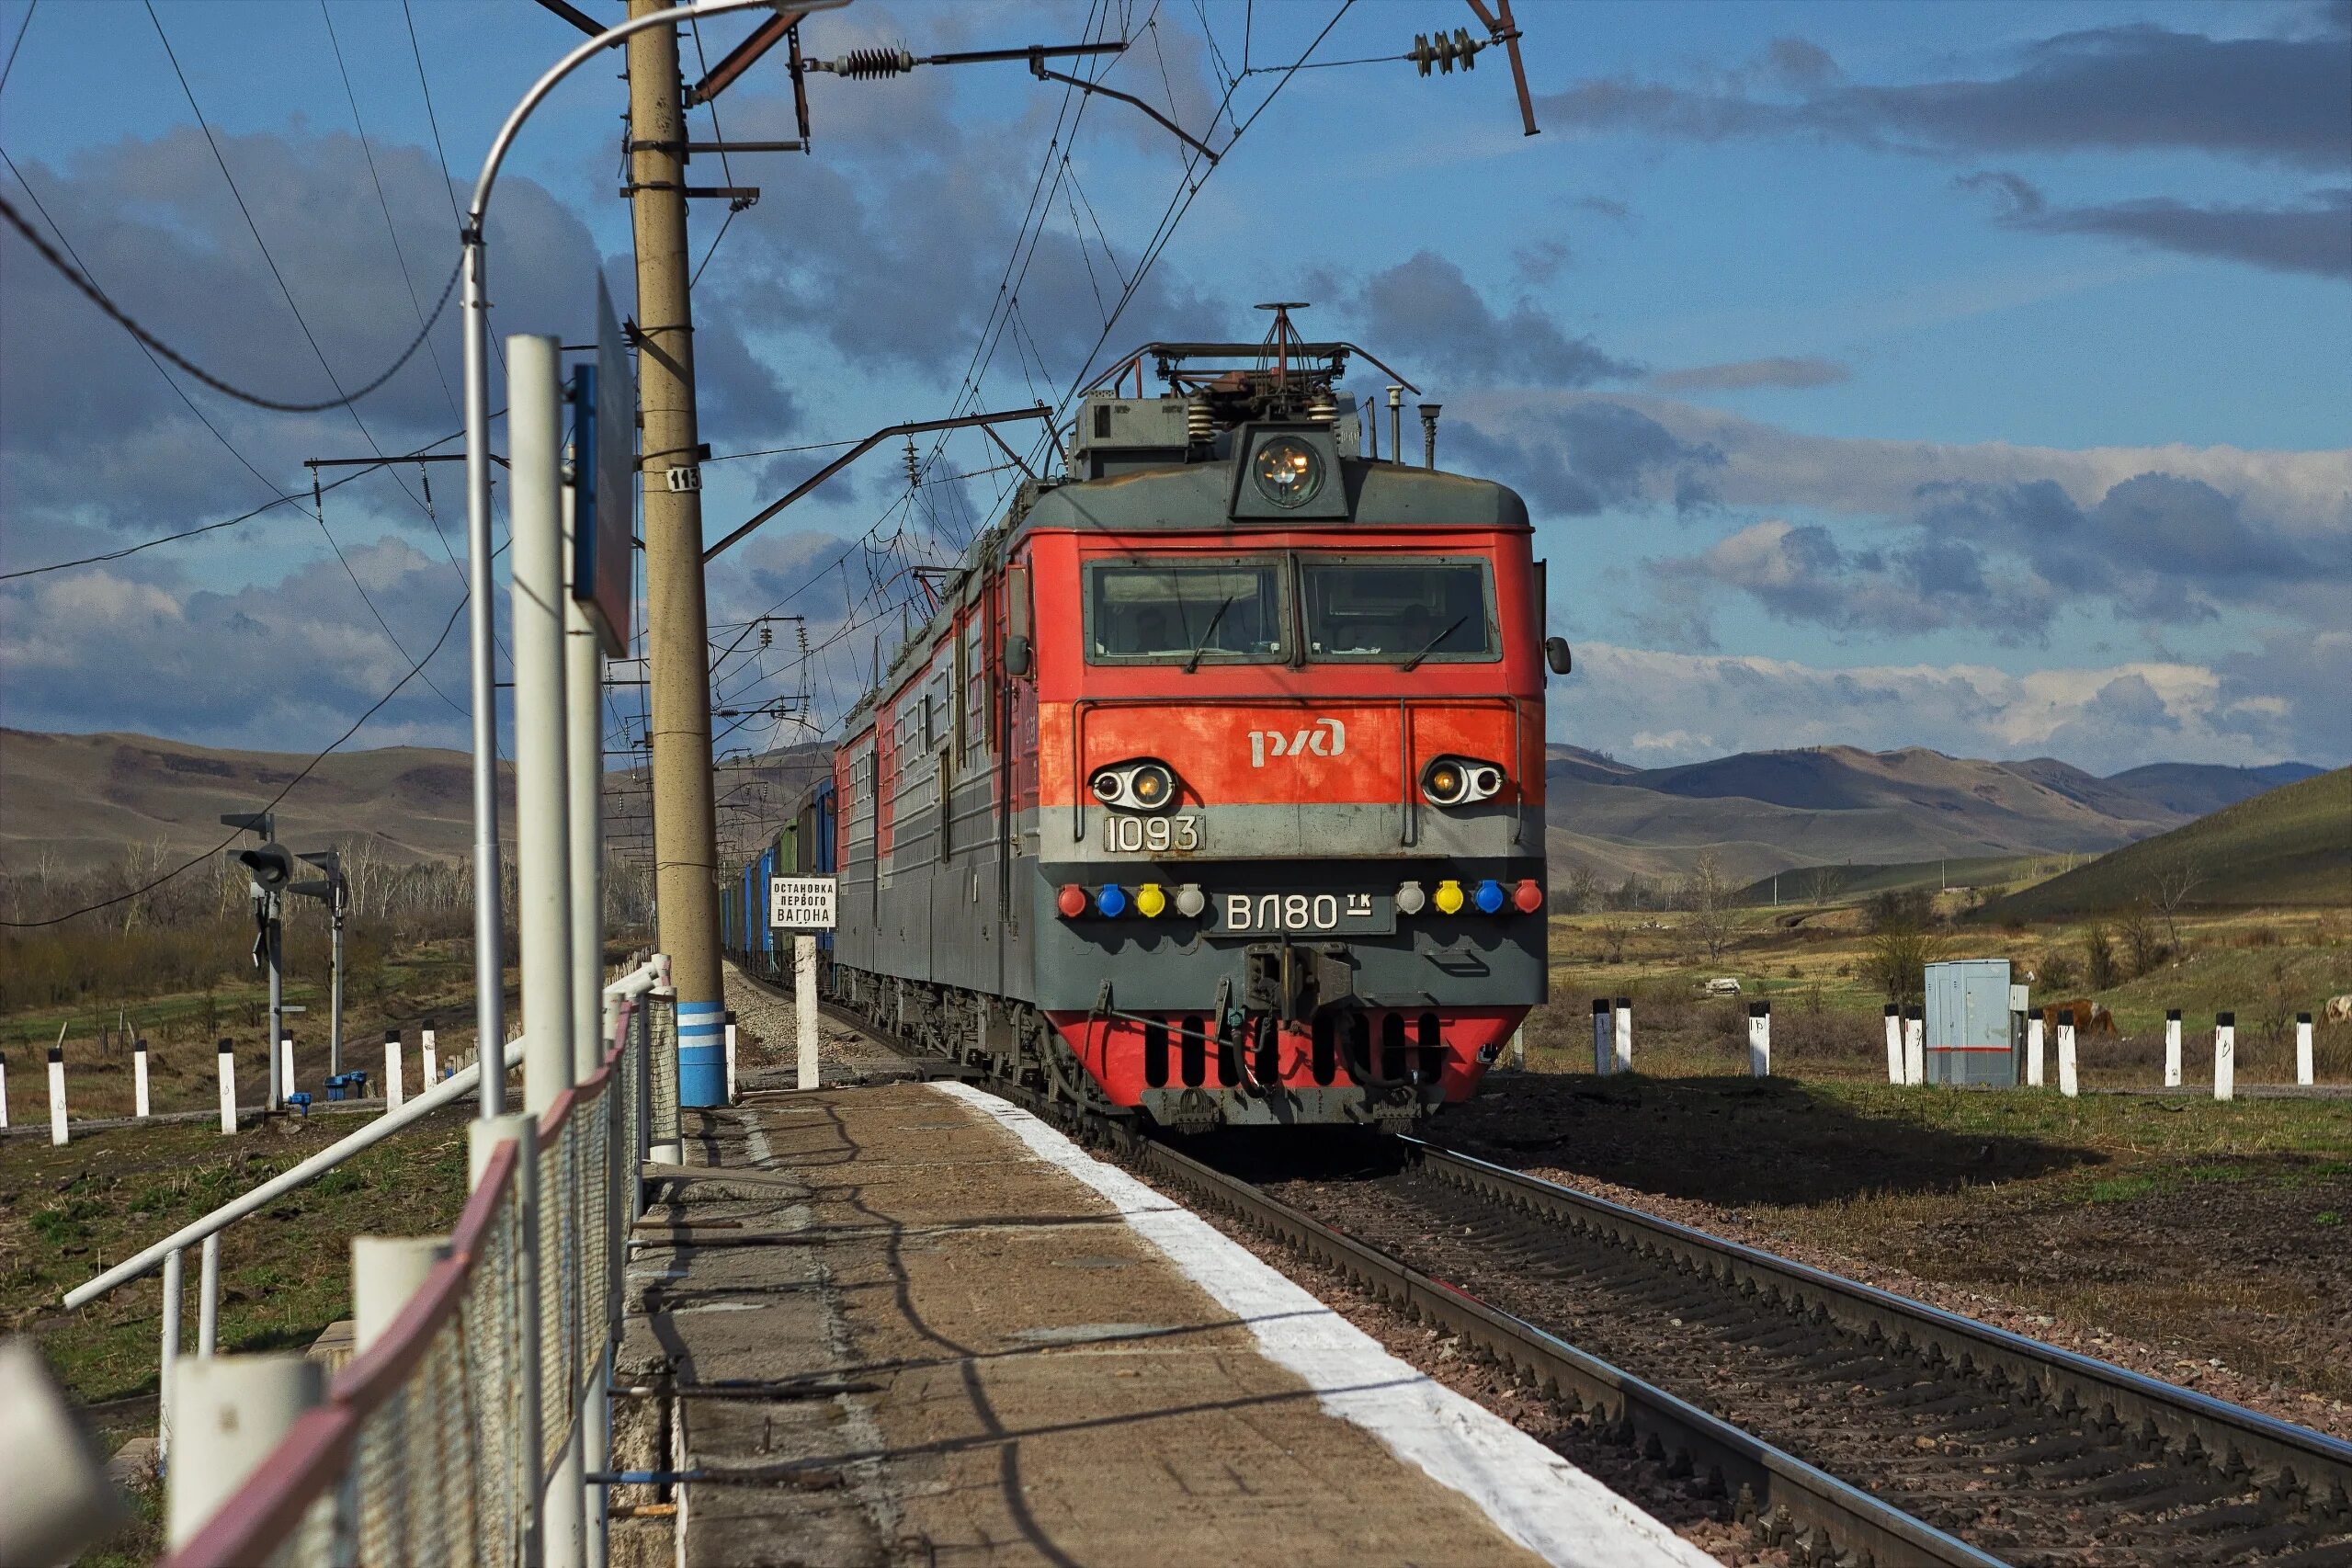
[727,312,1569,1131]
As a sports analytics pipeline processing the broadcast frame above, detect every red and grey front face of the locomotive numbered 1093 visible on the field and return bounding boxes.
[1016,346,1545,1129]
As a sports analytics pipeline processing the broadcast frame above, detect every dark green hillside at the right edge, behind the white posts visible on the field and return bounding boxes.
[1983,768,2352,919]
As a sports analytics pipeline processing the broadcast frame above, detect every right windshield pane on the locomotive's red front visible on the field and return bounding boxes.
[1299,555,1496,665]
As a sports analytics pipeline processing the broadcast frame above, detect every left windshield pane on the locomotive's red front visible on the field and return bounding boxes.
[1086,560,1289,665]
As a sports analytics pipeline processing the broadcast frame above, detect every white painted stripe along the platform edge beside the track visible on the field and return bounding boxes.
[931,1082,1715,1568]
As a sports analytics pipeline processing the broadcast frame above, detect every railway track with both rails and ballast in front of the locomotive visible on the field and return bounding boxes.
[724,968,2352,1568]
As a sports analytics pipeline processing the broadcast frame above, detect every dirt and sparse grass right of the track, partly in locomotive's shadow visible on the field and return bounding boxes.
[1437,1072,2352,1437]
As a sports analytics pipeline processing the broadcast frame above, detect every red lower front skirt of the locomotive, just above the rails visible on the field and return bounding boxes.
[1047,1006,1527,1105]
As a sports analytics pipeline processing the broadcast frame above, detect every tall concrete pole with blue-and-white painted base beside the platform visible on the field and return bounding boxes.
[628,0,727,1105]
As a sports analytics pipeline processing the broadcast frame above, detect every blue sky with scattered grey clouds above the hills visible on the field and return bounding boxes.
[0,0,2352,771]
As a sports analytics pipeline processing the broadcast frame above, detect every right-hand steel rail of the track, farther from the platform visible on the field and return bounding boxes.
[1400,1138,2352,1517]
